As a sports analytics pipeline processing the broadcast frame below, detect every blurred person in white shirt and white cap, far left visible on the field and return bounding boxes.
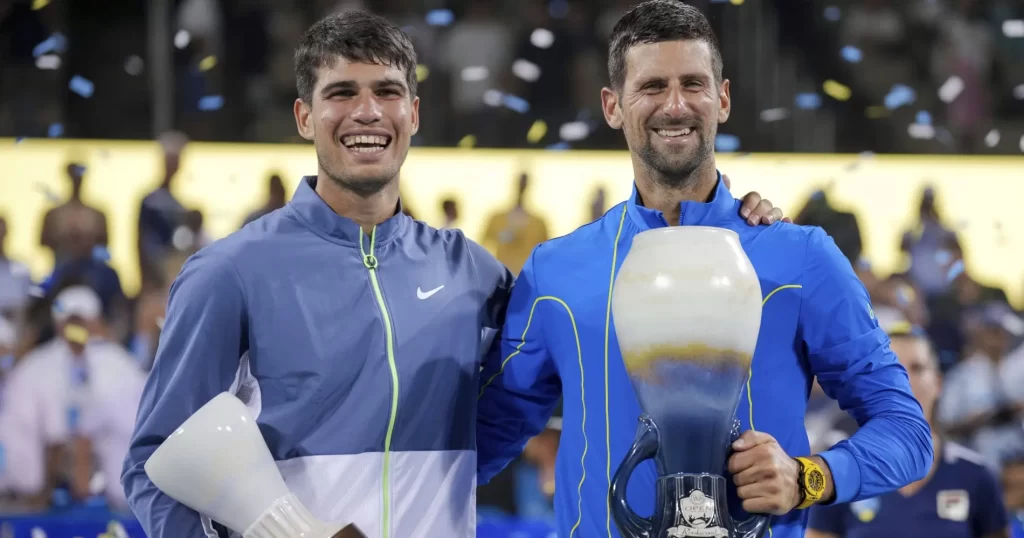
[0,286,145,510]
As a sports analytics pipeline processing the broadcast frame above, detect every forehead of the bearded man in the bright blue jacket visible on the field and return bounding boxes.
[626,39,714,80]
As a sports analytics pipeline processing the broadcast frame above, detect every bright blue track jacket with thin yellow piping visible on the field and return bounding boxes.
[477,175,932,538]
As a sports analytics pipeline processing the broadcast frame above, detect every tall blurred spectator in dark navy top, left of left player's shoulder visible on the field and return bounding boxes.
[138,132,187,281]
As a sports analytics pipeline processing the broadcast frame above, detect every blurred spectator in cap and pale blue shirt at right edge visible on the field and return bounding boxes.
[938,301,1024,468]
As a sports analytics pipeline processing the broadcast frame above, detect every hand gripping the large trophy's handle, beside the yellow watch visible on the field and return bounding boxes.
[728,430,801,515]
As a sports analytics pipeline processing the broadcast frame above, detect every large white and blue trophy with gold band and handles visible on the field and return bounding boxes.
[608,226,768,538]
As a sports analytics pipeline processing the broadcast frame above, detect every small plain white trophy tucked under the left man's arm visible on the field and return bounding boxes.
[145,392,366,538]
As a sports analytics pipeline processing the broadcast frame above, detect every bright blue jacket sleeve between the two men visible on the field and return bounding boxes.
[476,247,561,485]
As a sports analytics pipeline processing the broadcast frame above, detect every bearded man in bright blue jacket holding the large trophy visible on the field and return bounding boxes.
[477,0,932,538]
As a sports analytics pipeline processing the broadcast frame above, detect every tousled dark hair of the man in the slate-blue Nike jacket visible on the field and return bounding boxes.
[295,10,417,102]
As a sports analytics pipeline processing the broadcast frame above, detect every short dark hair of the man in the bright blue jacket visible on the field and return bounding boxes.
[608,0,722,91]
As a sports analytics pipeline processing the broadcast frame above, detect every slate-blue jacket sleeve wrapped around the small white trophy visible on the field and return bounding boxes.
[121,252,248,538]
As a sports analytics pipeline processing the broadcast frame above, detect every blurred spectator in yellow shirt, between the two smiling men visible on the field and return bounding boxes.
[483,173,548,274]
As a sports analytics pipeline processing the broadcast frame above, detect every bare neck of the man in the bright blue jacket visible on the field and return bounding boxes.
[633,158,718,225]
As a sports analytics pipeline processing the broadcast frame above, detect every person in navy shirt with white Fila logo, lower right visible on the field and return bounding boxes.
[807,322,1010,538]
